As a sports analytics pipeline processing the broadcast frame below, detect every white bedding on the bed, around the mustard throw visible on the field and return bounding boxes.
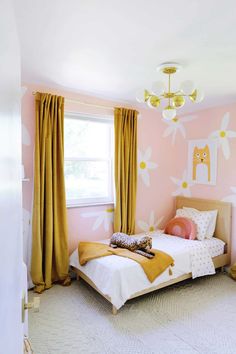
[70,233,224,309]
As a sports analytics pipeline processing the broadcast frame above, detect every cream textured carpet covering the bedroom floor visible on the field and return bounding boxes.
[29,274,236,354]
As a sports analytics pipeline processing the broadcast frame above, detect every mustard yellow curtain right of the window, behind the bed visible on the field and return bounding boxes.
[114,108,138,235]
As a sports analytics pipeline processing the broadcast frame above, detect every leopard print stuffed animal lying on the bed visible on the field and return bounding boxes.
[110,232,154,258]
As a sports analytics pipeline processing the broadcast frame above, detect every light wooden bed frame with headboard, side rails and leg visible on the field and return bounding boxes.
[72,196,232,315]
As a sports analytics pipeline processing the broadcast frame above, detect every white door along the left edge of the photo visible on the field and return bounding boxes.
[0,0,23,354]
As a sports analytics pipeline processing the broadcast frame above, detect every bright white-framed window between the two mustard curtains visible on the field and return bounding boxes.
[64,113,113,206]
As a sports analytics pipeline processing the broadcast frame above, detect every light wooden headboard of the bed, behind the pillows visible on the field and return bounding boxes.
[175,196,232,255]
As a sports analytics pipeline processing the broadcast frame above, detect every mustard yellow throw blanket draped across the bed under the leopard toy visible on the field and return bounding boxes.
[78,242,174,283]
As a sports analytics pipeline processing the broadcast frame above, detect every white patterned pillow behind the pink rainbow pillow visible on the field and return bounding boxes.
[176,209,211,241]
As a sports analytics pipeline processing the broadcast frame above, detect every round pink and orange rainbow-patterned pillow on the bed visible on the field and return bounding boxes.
[164,217,197,240]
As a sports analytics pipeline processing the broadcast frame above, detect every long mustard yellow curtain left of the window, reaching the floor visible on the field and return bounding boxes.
[31,93,70,293]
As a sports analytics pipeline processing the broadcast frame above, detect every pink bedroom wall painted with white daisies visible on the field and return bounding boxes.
[22,84,236,260]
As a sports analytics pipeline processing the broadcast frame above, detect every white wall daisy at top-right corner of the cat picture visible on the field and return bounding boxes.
[209,112,236,160]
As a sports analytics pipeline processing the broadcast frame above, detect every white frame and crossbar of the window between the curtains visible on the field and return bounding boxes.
[64,111,114,208]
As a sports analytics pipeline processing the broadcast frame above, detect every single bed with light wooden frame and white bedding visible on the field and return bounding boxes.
[70,196,231,314]
